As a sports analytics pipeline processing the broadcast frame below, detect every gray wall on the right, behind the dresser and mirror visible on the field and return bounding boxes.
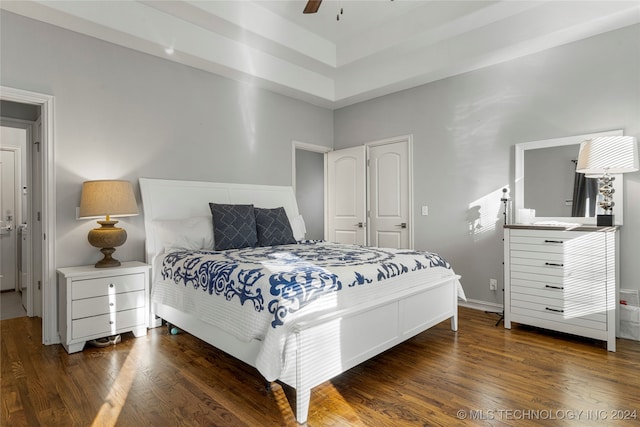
[334,25,640,303]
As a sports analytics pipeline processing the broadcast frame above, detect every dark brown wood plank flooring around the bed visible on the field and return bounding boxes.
[0,307,640,427]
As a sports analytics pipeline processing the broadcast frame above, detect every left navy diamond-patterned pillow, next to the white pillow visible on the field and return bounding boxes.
[209,203,258,251]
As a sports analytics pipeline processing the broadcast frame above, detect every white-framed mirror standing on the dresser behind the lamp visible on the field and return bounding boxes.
[513,130,623,225]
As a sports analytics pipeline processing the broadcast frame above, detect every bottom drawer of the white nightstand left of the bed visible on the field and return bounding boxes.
[71,307,145,339]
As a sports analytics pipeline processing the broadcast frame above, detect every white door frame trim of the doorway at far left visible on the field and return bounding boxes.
[0,86,60,345]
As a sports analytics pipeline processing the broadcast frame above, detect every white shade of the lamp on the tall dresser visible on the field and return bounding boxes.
[576,136,640,176]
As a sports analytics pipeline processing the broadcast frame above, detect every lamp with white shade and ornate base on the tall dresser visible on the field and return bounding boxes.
[576,136,640,226]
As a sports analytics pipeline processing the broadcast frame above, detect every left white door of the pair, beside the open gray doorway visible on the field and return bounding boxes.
[326,146,367,245]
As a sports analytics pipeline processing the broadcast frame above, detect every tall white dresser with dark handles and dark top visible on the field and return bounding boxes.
[504,225,618,351]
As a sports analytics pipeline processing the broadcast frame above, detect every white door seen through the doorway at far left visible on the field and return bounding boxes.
[0,147,20,291]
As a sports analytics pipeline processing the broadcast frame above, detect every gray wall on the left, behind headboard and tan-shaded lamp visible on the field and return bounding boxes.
[0,11,333,266]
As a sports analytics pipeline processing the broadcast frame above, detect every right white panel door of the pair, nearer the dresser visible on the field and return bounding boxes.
[369,140,411,248]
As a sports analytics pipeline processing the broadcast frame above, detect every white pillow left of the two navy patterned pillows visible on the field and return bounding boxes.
[153,215,213,252]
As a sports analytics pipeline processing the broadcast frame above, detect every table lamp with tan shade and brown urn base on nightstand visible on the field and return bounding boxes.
[79,180,138,268]
